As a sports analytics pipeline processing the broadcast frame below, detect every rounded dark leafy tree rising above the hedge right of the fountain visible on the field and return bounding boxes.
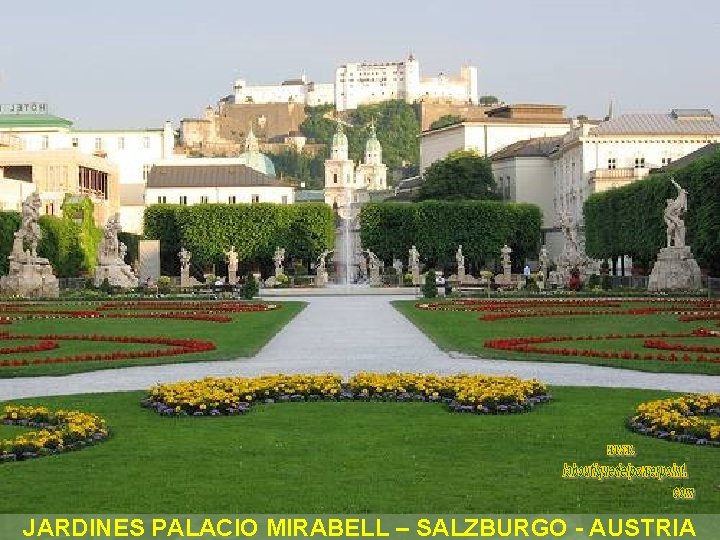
[417,150,499,201]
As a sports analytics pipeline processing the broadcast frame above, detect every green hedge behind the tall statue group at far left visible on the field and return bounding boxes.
[0,212,90,277]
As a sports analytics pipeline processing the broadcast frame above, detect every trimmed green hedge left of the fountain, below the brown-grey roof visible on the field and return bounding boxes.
[145,203,335,275]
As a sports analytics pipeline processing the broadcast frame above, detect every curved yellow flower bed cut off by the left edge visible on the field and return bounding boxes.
[0,405,110,463]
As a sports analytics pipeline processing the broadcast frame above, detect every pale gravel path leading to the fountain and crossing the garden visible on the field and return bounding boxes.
[0,296,720,401]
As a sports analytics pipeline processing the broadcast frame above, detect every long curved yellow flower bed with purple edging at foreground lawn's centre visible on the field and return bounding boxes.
[142,373,550,416]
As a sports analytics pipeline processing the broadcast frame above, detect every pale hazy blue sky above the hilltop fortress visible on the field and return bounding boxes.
[0,0,720,128]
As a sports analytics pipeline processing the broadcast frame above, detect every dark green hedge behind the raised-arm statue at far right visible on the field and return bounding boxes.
[583,148,720,275]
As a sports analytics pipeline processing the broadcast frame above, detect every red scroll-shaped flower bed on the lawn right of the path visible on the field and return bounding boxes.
[485,328,720,364]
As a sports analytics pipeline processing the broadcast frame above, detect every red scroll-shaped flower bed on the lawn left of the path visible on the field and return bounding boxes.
[0,332,215,368]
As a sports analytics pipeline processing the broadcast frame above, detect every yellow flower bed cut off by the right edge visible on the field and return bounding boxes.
[629,394,720,447]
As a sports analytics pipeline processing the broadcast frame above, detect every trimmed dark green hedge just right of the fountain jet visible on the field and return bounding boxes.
[360,201,542,271]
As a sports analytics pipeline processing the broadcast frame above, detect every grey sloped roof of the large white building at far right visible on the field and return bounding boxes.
[589,109,720,136]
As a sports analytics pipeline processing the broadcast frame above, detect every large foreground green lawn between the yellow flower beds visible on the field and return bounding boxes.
[0,388,720,514]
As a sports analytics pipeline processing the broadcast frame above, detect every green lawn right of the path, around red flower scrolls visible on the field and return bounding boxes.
[393,300,720,376]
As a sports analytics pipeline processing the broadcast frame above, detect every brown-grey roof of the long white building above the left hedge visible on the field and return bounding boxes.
[147,165,289,188]
